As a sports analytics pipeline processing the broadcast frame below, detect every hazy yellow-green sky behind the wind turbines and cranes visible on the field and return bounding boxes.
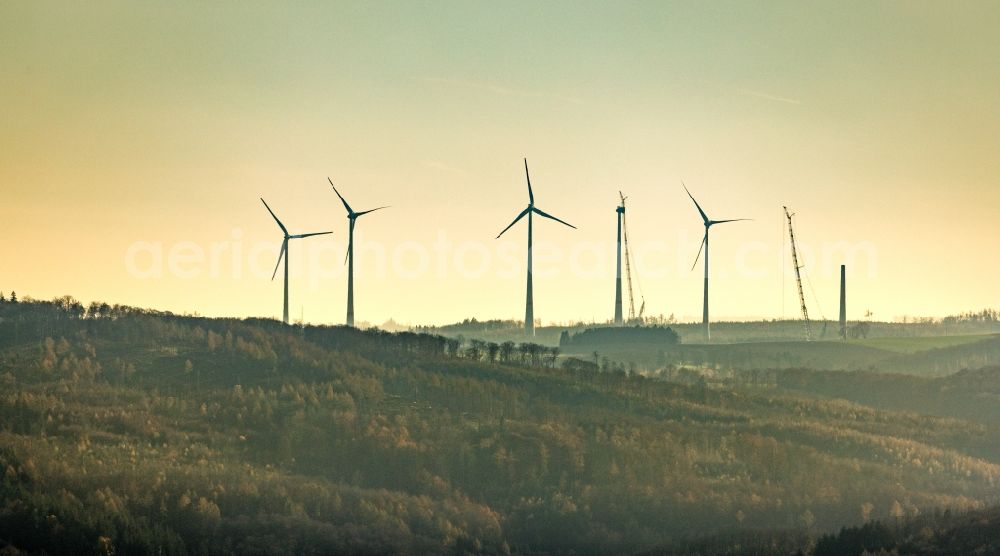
[0,1,1000,323]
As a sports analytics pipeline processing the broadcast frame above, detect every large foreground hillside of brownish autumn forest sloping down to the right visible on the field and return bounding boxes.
[0,299,1000,554]
